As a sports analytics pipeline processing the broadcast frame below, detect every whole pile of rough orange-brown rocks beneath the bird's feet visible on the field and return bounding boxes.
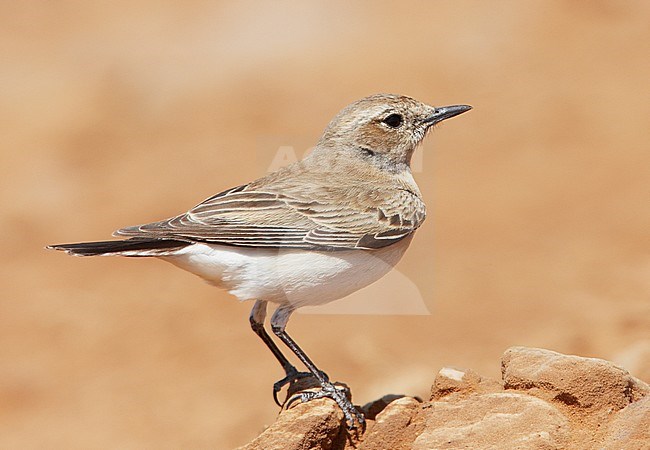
[242,347,650,450]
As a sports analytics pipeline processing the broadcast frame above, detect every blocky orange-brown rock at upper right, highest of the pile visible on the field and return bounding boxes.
[501,347,650,412]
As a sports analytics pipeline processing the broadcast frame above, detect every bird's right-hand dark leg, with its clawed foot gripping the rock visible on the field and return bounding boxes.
[271,305,365,429]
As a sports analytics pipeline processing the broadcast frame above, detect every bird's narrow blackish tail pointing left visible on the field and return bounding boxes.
[46,238,191,256]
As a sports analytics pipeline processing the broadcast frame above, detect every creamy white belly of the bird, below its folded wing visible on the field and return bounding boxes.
[161,236,411,307]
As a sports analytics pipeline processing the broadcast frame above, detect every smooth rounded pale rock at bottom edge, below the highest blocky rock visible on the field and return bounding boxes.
[412,392,570,450]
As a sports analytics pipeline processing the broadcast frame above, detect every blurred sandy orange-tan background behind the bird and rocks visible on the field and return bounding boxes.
[0,0,650,448]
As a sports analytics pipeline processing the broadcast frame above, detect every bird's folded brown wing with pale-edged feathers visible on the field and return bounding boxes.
[115,185,425,250]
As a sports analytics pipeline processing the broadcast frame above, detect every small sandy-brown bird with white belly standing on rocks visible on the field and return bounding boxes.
[47,94,472,429]
